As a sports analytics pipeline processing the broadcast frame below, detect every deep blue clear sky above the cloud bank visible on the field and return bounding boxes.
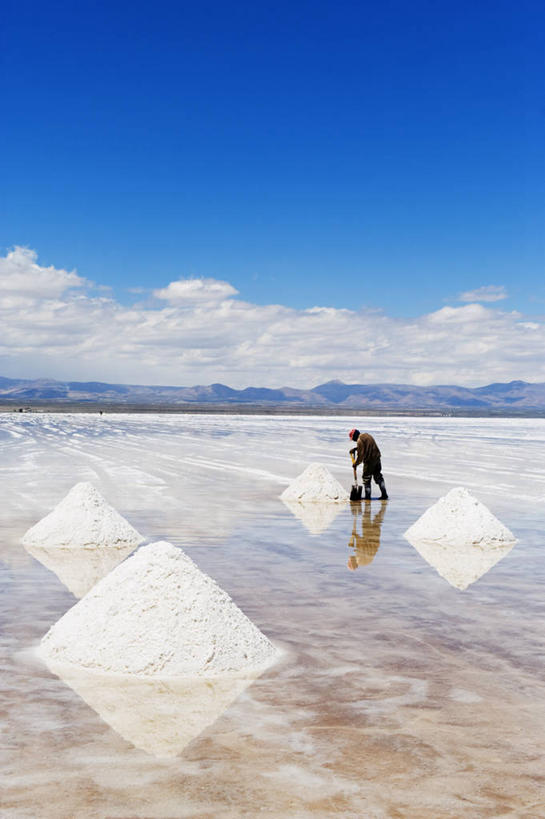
[0,0,545,388]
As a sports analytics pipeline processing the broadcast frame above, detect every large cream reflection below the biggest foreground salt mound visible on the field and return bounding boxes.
[47,660,259,757]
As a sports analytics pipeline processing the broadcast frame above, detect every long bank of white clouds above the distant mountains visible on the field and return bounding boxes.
[0,250,545,387]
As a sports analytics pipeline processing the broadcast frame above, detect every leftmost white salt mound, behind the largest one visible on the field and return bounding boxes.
[22,483,144,549]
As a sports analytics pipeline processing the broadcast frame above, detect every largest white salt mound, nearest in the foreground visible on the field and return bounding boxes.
[41,541,279,677]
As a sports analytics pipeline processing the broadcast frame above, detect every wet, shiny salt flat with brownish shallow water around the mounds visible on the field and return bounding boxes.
[0,416,545,817]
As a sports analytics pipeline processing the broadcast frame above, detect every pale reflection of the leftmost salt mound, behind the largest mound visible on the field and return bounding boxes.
[25,543,136,598]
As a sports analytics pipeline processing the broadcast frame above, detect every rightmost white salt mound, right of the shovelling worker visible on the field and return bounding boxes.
[405,486,516,546]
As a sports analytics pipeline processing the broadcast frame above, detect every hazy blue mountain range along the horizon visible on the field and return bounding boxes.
[0,377,545,412]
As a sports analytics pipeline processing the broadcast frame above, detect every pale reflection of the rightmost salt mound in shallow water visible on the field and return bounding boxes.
[407,538,515,591]
